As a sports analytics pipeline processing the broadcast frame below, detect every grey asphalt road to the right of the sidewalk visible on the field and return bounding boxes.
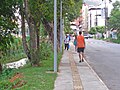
[85,39,120,90]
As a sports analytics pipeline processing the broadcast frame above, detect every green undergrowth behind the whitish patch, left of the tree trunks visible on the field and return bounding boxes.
[0,36,26,63]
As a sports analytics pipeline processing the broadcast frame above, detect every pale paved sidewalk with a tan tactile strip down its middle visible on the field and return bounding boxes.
[54,43,109,90]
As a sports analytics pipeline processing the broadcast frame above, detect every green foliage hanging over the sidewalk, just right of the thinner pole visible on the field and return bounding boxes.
[63,0,82,33]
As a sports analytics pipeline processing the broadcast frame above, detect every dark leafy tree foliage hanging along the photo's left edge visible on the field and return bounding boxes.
[0,0,17,72]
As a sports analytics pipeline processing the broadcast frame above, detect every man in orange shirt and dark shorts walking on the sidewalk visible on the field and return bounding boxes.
[77,31,85,62]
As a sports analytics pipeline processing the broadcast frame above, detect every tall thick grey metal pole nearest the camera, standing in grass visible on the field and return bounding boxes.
[54,0,57,72]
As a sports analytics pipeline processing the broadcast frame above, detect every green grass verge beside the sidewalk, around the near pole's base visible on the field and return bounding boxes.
[7,48,62,90]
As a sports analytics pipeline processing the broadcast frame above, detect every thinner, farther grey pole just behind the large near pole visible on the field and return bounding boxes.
[60,0,63,52]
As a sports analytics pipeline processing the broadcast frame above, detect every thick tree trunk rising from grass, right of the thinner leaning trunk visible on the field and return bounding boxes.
[24,0,39,66]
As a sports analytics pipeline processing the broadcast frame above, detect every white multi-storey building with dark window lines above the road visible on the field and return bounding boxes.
[88,0,115,31]
